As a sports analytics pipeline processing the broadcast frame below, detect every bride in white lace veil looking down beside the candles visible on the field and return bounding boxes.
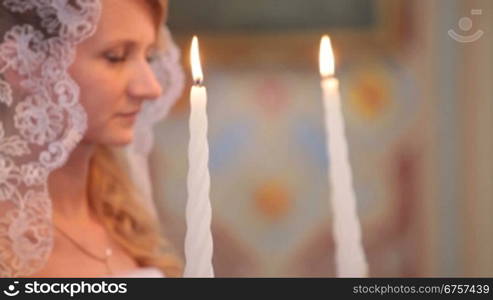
[0,0,182,277]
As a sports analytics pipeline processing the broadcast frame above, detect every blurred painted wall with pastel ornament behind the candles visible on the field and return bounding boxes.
[152,0,493,277]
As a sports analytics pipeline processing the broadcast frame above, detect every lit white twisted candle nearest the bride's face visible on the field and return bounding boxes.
[184,36,214,277]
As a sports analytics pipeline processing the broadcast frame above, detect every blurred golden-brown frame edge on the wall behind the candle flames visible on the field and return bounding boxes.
[176,0,412,68]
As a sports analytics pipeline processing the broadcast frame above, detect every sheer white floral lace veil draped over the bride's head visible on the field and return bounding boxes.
[0,0,184,277]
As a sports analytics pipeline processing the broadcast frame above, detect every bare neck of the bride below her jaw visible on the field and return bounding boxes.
[48,143,95,221]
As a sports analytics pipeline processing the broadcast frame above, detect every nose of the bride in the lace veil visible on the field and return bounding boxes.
[128,61,163,100]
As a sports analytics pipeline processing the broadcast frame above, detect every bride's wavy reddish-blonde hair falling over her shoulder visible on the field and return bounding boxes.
[87,0,183,277]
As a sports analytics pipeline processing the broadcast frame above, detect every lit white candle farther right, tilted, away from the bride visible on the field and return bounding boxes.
[320,36,368,277]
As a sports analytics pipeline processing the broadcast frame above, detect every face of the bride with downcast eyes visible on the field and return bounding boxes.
[69,0,161,145]
